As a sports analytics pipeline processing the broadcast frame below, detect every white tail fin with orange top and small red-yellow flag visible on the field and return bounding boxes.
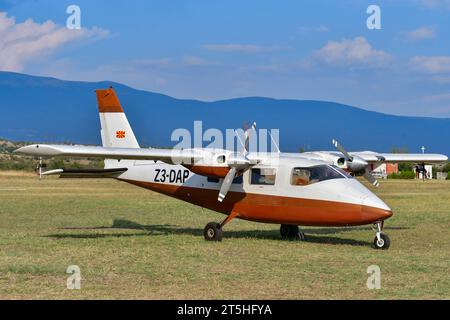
[95,87,139,148]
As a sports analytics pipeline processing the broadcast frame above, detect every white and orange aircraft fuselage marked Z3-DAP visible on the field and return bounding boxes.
[117,154,392,226]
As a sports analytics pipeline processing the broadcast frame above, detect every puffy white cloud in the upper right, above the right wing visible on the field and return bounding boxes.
[314,37,391,66]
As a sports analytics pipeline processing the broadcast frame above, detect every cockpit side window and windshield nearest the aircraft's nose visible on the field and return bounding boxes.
[291,165,348,186]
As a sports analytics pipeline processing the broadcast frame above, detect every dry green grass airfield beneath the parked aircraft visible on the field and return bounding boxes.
[0,173,450,299]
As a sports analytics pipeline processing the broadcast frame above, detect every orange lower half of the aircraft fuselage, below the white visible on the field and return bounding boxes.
[120,179,392,226]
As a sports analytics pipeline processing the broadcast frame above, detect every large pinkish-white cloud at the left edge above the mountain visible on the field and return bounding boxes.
[0,12,108,71]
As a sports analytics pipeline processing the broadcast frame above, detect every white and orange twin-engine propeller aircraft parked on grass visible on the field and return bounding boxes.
[16,88,447,249]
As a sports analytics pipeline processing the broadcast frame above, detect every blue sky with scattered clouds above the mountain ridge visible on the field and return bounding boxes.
[0,0,450,117]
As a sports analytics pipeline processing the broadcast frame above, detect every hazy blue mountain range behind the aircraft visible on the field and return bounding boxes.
[0,72,450,155]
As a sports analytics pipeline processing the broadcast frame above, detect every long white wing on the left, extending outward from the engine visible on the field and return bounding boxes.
[15,144,203,164]
